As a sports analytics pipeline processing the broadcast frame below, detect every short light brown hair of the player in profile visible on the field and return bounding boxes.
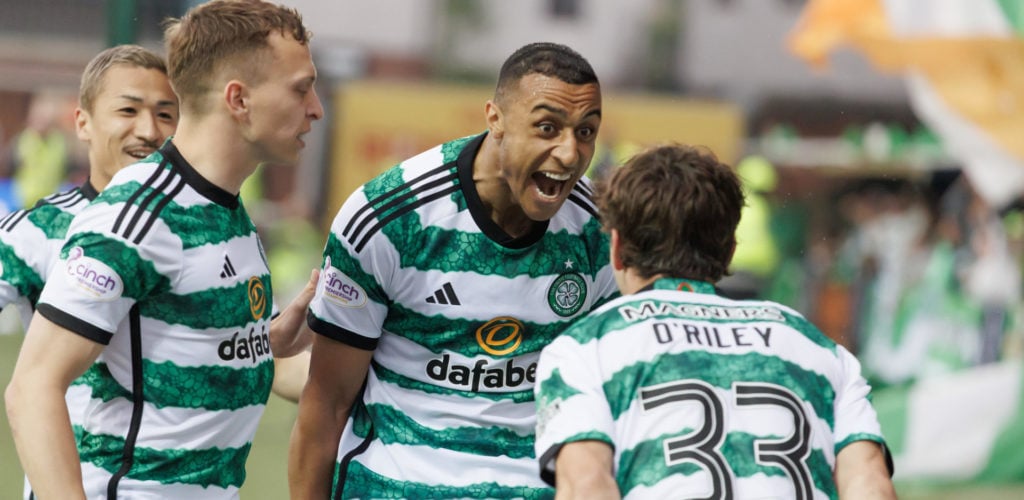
[164,0,310,112]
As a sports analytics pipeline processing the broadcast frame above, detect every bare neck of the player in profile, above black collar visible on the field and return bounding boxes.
[167,114,258,195]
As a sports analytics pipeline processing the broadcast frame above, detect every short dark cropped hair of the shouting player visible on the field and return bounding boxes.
[495,42,598,100]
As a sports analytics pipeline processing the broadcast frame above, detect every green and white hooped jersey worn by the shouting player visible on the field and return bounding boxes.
[309,135,617,498]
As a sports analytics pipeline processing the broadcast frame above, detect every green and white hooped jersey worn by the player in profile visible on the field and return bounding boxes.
[39,141,273,500]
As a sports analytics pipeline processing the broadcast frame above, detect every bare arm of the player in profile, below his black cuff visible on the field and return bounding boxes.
[5,313,103,499]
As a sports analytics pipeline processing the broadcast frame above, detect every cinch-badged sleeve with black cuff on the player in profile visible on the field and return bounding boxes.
[38,198,182,344]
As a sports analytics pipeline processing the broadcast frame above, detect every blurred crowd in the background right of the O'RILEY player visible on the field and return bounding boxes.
[745,157,1024,387]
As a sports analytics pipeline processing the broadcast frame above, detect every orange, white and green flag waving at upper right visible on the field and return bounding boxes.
[790,0,1024,206]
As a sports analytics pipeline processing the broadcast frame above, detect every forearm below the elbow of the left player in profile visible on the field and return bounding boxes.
[6,378,85,499]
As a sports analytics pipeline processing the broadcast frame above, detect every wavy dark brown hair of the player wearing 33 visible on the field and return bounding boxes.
[597,144,744,283]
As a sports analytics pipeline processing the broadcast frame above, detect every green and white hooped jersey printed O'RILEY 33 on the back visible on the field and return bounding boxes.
[537,279,884,499]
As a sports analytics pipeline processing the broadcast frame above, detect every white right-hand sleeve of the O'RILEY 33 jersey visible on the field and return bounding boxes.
[835,345,885,454]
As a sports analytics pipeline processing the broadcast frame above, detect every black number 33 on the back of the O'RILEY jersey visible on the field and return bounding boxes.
[640,380,812,500]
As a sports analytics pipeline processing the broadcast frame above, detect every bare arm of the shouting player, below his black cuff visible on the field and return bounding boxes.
[288,335,373,500]
